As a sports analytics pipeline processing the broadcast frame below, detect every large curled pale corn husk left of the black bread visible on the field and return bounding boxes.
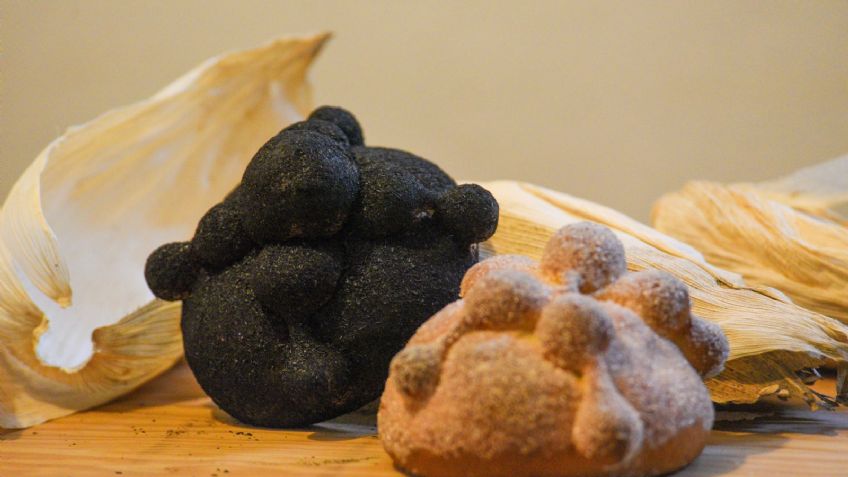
[0,35,327,428]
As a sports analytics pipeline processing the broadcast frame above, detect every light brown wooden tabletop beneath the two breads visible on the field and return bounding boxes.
[0,364,848,477]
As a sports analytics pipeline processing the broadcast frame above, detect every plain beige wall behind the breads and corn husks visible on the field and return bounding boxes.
[0,0,848,220]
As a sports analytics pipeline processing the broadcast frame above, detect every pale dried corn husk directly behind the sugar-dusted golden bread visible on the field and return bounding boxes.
[483,182,848,407]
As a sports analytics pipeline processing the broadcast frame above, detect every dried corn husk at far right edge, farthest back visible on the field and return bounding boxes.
[653,156,848,324]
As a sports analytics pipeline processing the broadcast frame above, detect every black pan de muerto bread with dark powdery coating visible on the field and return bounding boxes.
[145,107,498,427]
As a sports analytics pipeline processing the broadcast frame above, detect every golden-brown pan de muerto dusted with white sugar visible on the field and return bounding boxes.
[378,222,728,477]
